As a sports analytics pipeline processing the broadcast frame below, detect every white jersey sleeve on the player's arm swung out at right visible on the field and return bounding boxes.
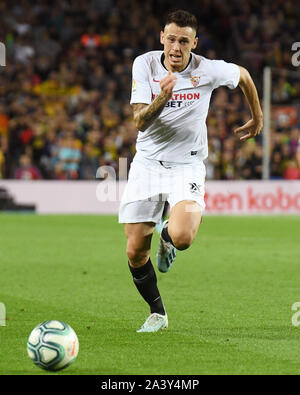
[212,60,240,89]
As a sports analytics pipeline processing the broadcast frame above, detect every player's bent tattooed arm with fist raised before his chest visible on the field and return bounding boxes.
[132,71,177,132]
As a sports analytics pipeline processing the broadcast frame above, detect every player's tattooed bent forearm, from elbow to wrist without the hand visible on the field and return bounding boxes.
[132,94,170,132]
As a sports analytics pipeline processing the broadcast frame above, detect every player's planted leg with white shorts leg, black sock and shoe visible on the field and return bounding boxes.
[119,155,168,332]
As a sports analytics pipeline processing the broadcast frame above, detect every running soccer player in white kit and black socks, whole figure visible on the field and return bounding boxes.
[119,10,263,332]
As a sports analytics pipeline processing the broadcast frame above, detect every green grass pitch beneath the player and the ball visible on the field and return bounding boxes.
[0,214,300,375]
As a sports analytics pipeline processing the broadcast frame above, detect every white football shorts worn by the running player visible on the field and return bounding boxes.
[119,153,206,223]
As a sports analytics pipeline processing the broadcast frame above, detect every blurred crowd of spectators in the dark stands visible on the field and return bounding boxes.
[0,0,300,180]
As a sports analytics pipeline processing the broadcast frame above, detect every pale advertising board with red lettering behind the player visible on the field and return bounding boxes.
[0,180,300,215]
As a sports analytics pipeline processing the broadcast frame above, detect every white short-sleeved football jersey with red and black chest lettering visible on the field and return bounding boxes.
[130,51,240,163]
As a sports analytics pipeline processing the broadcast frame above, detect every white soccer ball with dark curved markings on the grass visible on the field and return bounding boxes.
[27,321,79,371]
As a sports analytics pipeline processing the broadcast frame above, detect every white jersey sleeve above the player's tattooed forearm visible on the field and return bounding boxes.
[130,56,152,104]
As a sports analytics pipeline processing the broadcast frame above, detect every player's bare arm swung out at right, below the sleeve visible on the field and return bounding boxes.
[234,66,263,141]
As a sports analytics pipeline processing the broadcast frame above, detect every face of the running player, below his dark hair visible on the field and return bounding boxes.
[160,23,198,72]
